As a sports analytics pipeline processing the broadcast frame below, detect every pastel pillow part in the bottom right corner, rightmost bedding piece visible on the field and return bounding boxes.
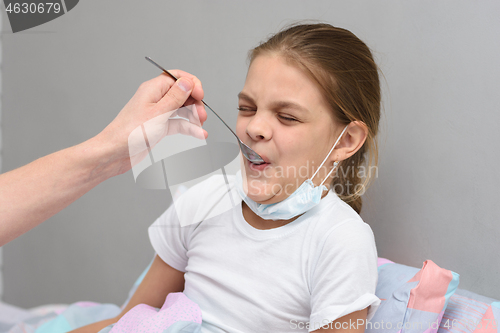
[438,289,500,333]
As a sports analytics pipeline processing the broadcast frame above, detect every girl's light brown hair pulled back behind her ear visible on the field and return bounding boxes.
[249,23,381,213]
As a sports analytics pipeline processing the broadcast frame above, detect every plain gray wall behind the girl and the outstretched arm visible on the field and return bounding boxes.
[0,0,500,307]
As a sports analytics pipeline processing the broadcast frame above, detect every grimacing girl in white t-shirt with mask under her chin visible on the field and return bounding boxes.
[77,24,380,332]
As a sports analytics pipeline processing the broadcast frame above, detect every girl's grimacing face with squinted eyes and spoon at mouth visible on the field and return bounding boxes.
[236,54,343,204]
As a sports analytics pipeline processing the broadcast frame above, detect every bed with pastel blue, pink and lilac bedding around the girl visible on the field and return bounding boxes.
[0,258,500,333]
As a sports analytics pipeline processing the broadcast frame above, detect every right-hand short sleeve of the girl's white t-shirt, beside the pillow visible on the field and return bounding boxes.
[310,219,380,327]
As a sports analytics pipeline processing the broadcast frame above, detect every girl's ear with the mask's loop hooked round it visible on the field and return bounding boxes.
[331,120,368,161]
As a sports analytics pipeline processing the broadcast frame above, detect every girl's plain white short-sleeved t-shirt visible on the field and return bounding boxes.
[149,176,380,332]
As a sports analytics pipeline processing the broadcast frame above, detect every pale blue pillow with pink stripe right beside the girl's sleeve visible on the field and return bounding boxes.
[366,258,459,333]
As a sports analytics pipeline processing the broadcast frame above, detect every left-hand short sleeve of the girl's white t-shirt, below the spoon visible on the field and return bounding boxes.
[148,204,192,272]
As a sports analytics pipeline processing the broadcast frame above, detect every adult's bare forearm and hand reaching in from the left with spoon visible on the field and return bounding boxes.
[0,70,207,246]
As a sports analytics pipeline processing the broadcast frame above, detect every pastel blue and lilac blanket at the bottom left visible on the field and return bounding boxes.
[0,293,201,333]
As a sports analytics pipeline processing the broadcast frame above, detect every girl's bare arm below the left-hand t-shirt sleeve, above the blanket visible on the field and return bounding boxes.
[66,256,184,333]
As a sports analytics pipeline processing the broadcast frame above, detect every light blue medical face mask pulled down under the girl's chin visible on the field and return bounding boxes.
[236,126,347,220]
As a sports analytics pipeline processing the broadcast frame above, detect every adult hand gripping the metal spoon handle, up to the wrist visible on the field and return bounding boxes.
[94,70,208,175]
